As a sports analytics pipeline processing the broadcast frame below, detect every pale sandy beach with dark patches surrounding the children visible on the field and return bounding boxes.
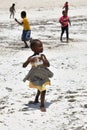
[0,0,87,130]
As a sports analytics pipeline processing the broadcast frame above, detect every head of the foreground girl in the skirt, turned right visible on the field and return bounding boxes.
[30,39,43,54]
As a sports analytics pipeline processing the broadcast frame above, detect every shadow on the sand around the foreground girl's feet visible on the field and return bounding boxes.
[22,102,52,111]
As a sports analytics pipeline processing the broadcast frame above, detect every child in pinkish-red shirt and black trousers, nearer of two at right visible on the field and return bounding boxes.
[59,11,71,42]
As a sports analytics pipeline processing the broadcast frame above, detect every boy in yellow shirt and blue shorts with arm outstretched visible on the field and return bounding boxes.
[15,11,31,48]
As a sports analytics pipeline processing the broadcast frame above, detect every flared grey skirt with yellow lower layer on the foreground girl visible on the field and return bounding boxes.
[23,65,53,91]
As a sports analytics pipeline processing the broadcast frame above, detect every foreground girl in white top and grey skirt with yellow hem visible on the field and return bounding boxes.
[23,39,53,112]
